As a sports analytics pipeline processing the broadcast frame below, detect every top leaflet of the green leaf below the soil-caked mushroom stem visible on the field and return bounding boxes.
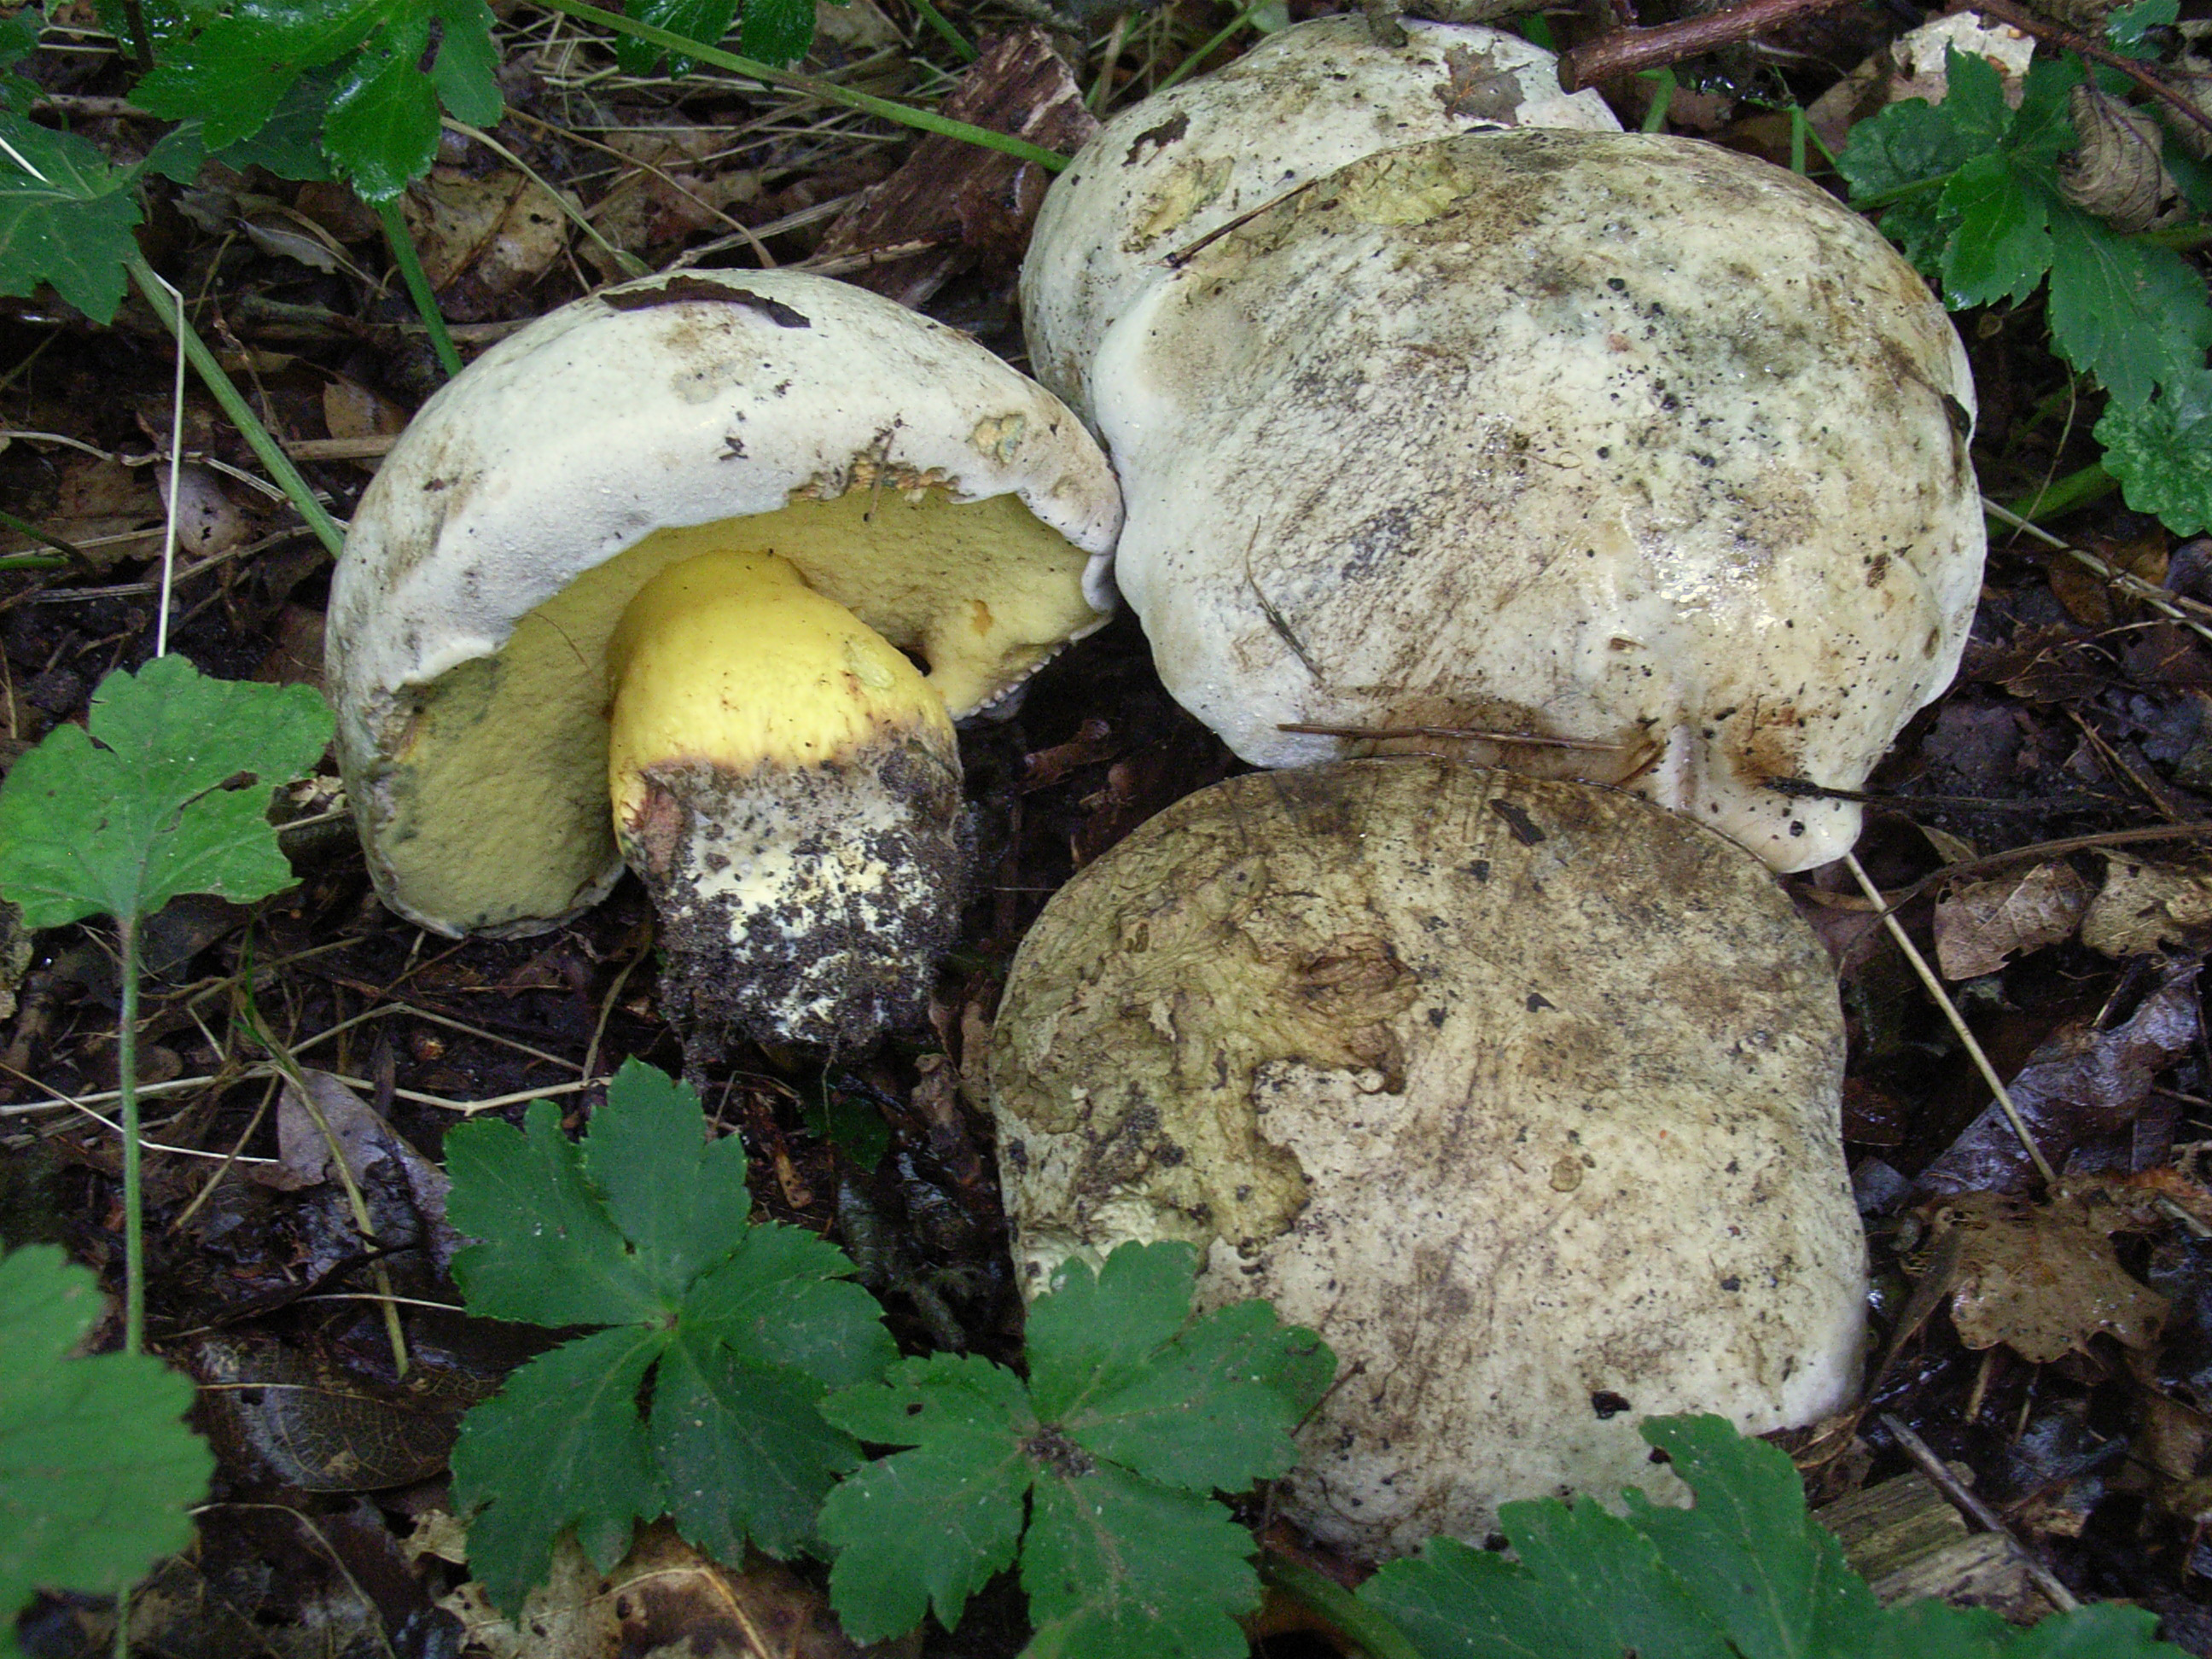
[584,1060,752,1296]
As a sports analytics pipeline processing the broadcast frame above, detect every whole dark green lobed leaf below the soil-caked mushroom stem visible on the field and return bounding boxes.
[447,1062,896,1610]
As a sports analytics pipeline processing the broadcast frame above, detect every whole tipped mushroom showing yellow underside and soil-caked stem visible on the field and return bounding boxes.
[328,272,1120,1046]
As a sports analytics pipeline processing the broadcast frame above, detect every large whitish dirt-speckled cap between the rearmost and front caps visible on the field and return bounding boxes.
[1092,131,1984,870]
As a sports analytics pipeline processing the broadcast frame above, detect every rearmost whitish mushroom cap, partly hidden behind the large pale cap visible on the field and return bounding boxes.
[1022,15,1619,420]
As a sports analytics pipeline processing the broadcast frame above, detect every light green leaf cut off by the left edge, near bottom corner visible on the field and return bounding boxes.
[0,1245,214,1630]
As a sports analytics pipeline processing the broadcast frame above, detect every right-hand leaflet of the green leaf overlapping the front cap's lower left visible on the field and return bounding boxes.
[1062,1303,1334,1493]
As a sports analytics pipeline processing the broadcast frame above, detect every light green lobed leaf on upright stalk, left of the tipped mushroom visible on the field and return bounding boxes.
[0,657,332,927]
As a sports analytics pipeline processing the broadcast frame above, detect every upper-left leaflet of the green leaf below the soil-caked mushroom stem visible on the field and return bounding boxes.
[445,1095,675,1327]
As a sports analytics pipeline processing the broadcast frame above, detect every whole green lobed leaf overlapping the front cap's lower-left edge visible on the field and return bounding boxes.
[821,1243,1336,1659]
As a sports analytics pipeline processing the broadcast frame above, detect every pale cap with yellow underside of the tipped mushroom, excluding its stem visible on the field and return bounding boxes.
[328,272,1121,934]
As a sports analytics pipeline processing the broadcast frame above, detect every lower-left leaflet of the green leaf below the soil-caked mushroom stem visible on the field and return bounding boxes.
[453,1325,668,1617]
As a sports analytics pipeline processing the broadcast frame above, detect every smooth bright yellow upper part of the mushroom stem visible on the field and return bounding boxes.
[606,553,956,825]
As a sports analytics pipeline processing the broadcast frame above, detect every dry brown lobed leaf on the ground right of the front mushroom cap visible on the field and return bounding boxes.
[1927,1192,2166,1365]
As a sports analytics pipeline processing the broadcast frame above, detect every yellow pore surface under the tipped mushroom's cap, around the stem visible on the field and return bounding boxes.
[376,486,1097,934]
